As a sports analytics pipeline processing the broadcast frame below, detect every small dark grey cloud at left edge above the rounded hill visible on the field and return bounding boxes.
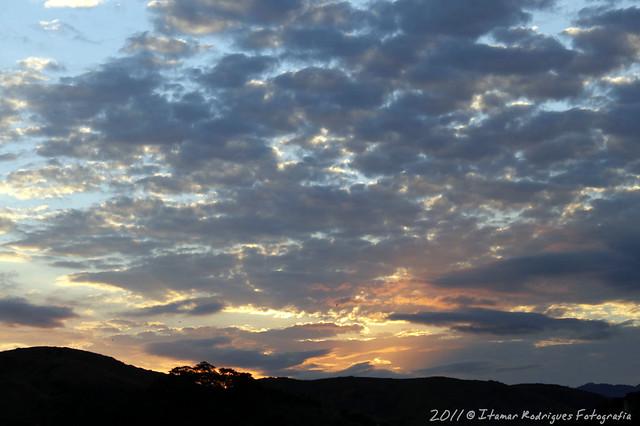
[0,298,76,328]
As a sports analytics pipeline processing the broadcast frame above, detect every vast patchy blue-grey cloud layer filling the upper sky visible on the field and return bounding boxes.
[7,0,638,310]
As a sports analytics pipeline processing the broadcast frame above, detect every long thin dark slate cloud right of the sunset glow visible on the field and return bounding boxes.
[389,308,616,340]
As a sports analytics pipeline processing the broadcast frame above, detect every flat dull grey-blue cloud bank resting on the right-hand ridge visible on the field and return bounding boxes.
[414,327,638,386]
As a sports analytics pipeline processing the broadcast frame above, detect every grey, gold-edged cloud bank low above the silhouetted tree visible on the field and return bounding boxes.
[88,318,360,376]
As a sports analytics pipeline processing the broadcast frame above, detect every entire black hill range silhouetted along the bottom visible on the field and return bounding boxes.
[0,348,637,426]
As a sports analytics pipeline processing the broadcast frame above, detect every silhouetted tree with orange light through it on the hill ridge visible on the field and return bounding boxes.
[169,361,253,389]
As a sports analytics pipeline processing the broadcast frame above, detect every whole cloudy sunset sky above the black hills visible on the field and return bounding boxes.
[0,0,640,386]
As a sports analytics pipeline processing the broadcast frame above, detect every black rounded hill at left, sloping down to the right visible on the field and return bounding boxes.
[0,347,368,426]
